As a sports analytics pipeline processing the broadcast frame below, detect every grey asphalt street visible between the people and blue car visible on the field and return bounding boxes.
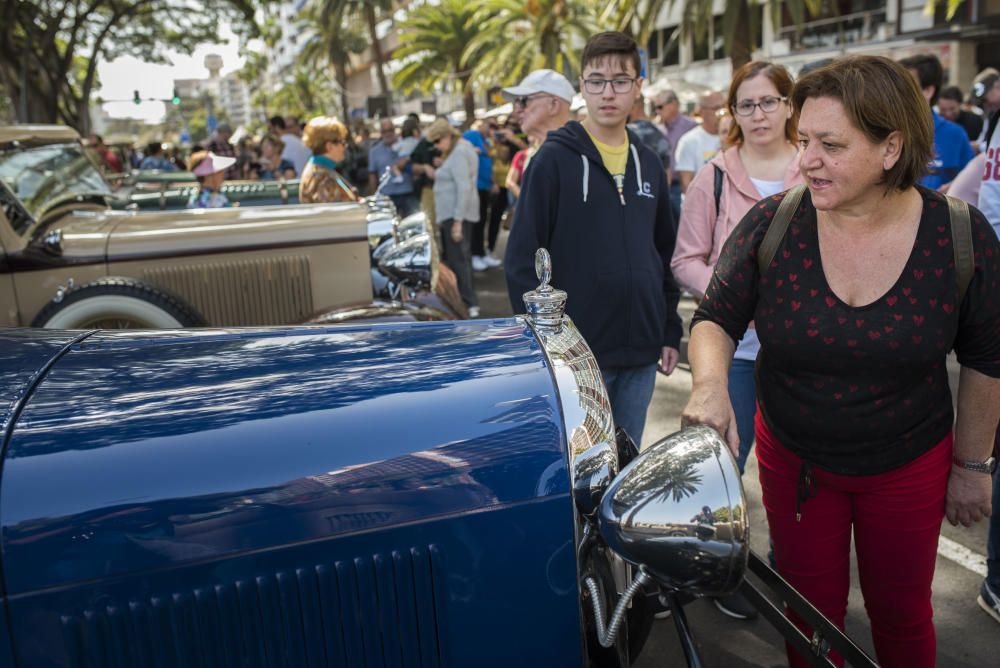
[475,228,1000,668]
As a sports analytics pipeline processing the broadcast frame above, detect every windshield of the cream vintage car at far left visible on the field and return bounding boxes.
[0,144,111,226]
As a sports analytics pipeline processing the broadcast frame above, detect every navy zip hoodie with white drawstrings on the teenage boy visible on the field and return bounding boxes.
[504,121,682,368]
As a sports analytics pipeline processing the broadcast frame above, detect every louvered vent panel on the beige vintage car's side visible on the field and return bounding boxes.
[143,256,314,327]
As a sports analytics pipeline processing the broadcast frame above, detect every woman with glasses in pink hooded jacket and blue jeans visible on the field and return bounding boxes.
[670,61,802,480]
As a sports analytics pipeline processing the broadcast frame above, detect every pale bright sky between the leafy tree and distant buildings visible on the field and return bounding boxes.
[95,25,243,123]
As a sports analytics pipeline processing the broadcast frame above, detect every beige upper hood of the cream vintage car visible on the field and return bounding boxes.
[49,202,368,261]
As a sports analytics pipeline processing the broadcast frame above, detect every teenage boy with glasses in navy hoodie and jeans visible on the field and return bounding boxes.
[505,32,681,443]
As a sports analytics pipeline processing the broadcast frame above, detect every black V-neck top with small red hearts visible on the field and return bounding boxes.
[692,188,1000,475]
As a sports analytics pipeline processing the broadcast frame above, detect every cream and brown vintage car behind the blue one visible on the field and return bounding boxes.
[0,126,464,329]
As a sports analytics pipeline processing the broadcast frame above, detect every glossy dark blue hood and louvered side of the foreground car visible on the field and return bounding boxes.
[0,320,582,666]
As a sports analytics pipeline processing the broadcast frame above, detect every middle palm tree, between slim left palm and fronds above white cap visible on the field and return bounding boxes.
[392,0,491,120]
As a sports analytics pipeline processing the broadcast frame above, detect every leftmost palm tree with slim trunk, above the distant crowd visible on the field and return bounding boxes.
[298,2,368,121]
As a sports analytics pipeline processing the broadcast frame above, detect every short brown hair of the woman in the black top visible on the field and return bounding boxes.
[792,56,934,190]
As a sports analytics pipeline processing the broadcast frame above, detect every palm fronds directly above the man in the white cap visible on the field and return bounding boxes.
[469,0,599,82]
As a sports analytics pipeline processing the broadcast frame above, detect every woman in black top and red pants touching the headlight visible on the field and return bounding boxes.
[682,56,1000,668]
